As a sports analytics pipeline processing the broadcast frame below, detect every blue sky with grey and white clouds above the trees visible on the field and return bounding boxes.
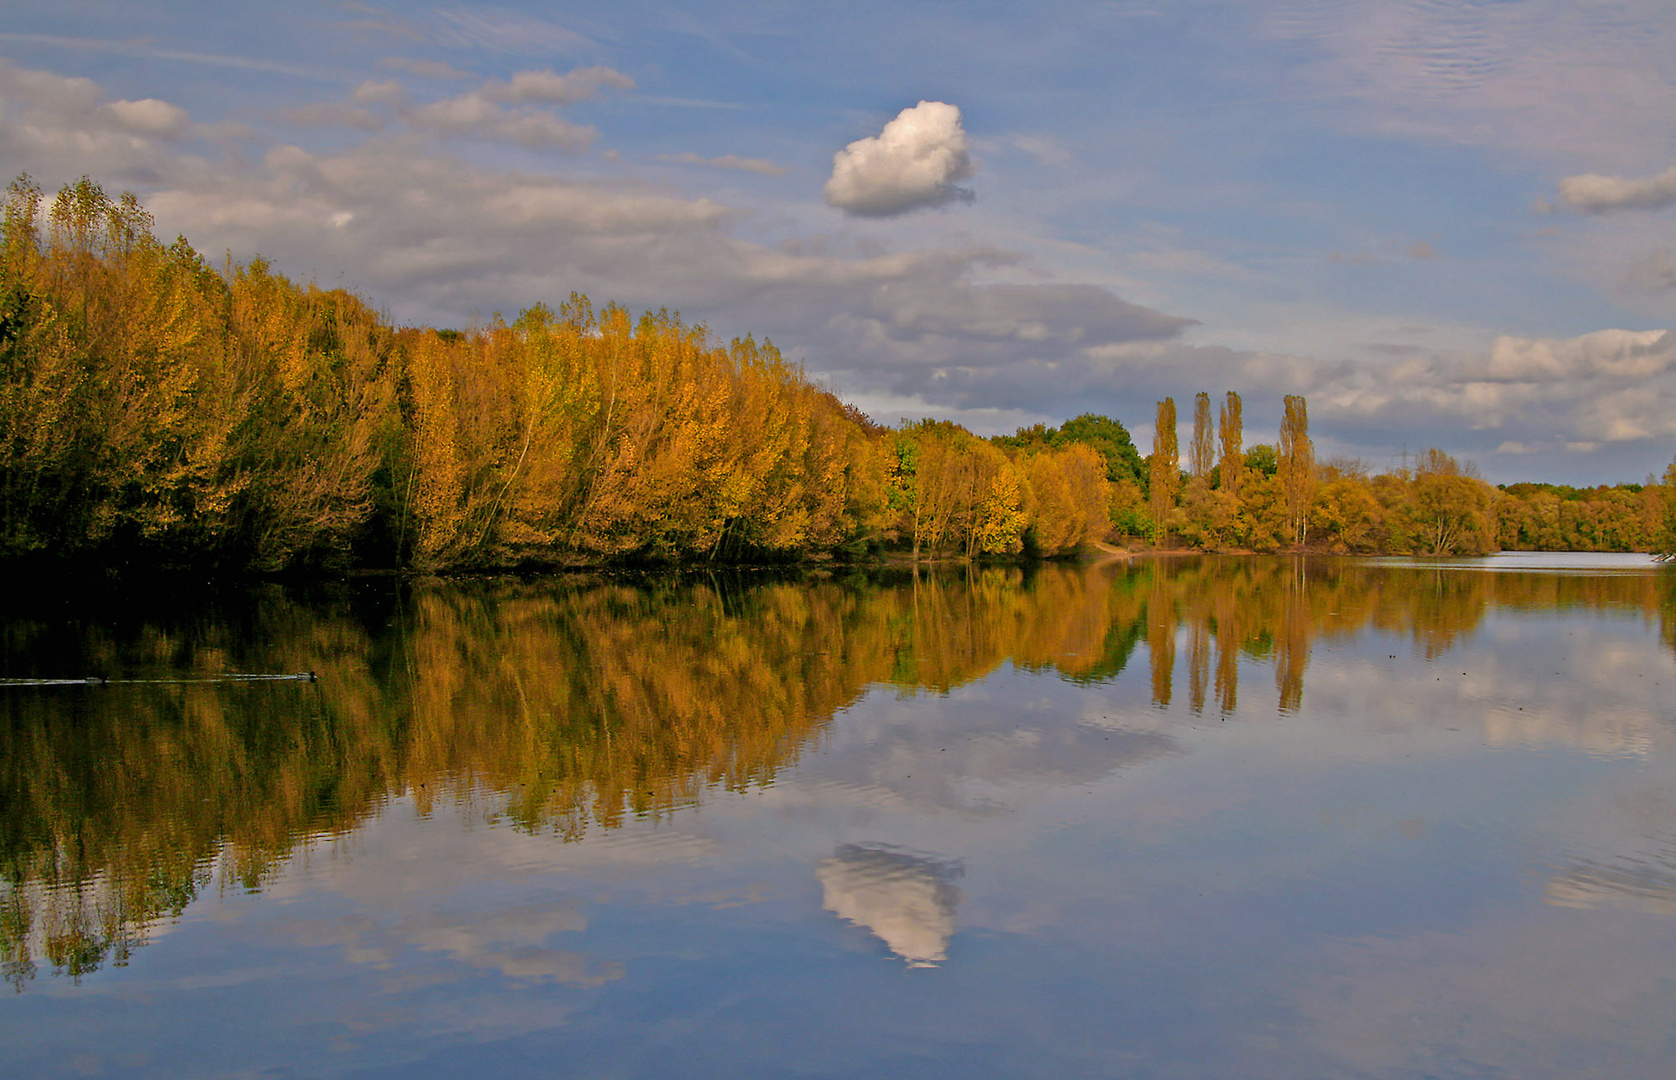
[0,0,1676,485]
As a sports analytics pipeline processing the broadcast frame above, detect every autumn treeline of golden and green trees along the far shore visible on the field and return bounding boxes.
[0,178,1676,572]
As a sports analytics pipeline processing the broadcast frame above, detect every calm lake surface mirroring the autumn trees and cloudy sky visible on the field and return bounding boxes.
[0,557,1676,1078]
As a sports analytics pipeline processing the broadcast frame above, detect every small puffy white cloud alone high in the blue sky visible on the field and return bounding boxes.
[825,101,977,218]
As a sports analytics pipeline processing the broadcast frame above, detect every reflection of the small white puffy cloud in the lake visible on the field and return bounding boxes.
[815,844,962,968]
